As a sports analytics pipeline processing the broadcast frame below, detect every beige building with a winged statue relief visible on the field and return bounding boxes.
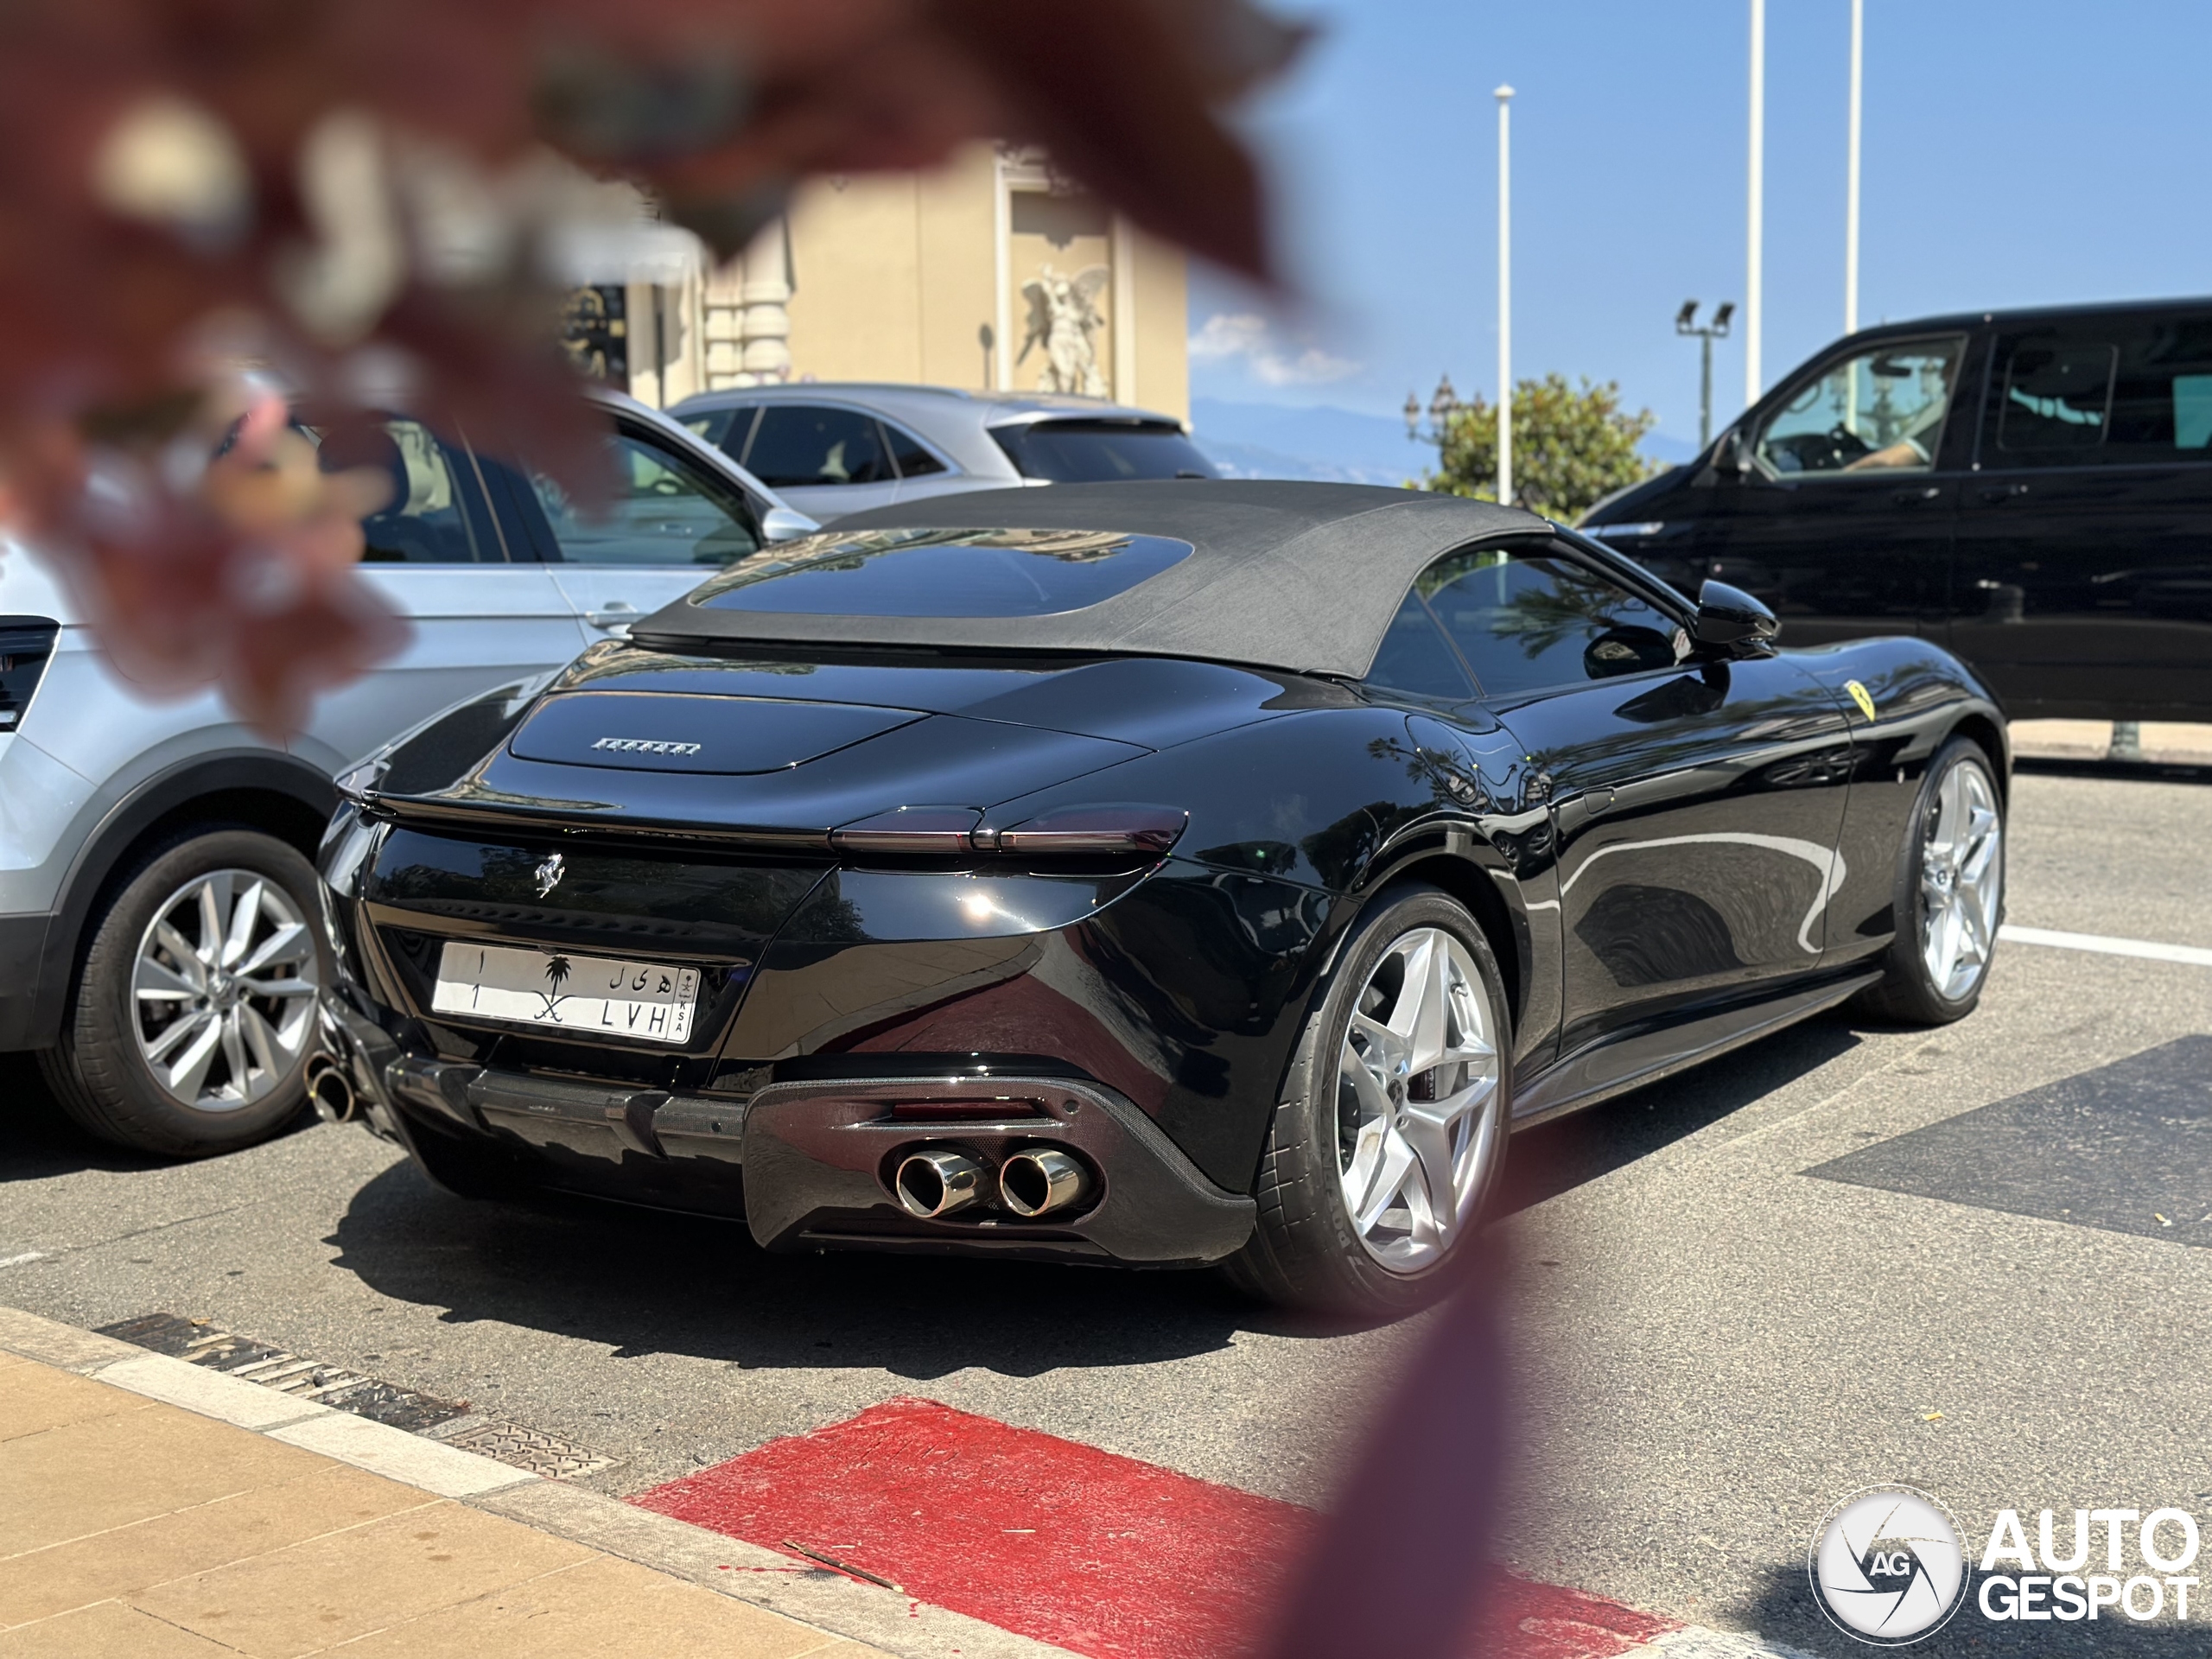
[597,146,1190,420]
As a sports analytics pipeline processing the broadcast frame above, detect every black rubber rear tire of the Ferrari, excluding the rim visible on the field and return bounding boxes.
[1225,882,1513,1319]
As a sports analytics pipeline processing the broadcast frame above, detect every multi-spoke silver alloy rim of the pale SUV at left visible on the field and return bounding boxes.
[130,869,321,1113]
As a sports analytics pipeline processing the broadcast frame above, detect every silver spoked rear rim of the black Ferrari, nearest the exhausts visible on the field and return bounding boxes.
[1336,927,1502,1272]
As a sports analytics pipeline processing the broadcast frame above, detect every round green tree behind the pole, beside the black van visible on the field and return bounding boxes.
[1422,374,1656,522]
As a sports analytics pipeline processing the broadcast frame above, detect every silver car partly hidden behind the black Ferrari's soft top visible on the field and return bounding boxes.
[668,380,1214,522]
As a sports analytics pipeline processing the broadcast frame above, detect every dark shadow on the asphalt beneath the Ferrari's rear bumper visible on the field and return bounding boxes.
[325,1164,1325,1380]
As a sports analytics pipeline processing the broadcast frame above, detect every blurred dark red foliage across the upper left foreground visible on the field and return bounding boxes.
[0,0,1299,732]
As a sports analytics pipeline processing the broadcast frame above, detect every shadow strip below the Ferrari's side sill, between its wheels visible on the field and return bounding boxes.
[1491,1011,1863,1217]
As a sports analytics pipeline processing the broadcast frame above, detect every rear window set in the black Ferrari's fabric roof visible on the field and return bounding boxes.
[692,531,1190,617]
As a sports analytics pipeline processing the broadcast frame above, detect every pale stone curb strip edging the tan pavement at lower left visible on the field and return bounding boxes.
[0,1305,1071,1659]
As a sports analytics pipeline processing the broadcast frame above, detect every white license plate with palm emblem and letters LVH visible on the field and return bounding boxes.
[429,943,699,1042]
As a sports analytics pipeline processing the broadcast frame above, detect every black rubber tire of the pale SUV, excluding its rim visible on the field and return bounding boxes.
[38,825,332,1157]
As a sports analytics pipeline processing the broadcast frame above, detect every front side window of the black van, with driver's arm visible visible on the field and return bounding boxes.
[1757,339,1964,478]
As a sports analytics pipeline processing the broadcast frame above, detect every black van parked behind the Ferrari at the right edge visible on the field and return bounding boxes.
[1584,299,2212,719]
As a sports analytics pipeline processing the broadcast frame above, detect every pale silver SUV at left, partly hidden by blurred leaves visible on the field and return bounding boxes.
[0,391,817,1154]
